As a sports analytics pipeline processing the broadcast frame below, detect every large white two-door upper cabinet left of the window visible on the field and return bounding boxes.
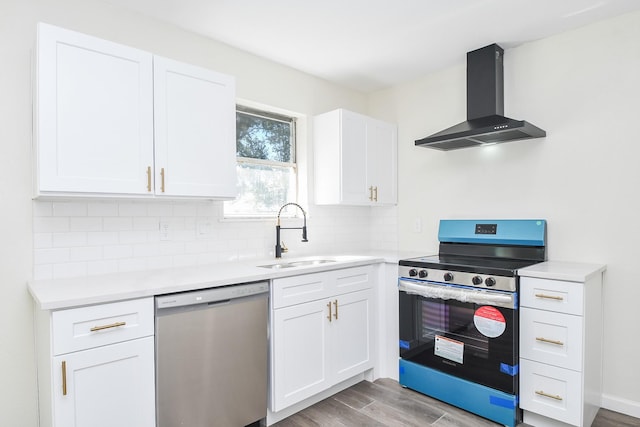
[34,23,236,199]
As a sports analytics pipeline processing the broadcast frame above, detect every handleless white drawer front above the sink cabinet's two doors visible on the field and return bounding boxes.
[272,266,374,308]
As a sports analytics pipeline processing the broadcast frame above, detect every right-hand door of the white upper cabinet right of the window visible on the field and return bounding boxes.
[367,119,398,205]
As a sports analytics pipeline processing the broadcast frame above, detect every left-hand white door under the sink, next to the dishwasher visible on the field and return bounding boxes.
[271,300,330,412]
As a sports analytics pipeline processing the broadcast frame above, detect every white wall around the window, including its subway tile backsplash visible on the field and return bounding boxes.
[0,0,397,427]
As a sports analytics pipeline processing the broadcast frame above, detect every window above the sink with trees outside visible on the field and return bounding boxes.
[224,105,297,217]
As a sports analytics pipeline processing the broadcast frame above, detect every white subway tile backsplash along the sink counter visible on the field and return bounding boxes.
[33,200,390,280]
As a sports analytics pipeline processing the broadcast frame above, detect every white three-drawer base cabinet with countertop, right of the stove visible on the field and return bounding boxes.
[518,262,605,427]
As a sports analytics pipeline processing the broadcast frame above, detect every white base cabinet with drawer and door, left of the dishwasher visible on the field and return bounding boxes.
[37,298,155,427]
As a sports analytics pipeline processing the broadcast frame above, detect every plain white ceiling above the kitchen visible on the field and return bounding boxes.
[103,0,640,93]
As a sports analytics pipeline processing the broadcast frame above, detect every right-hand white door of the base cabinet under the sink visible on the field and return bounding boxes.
[327,290,373,383]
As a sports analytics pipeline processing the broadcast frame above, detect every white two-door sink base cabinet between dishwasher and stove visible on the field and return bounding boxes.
[270,266,374,412]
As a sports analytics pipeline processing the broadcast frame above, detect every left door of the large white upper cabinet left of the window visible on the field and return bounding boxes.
[36,24,153,195]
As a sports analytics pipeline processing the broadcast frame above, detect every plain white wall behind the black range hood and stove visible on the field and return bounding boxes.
[370,13,640,416]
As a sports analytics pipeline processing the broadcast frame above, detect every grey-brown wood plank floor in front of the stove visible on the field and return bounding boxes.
[274,379,640,427]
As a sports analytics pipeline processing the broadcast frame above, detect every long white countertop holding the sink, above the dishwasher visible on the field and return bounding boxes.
[28,252,416,310]
